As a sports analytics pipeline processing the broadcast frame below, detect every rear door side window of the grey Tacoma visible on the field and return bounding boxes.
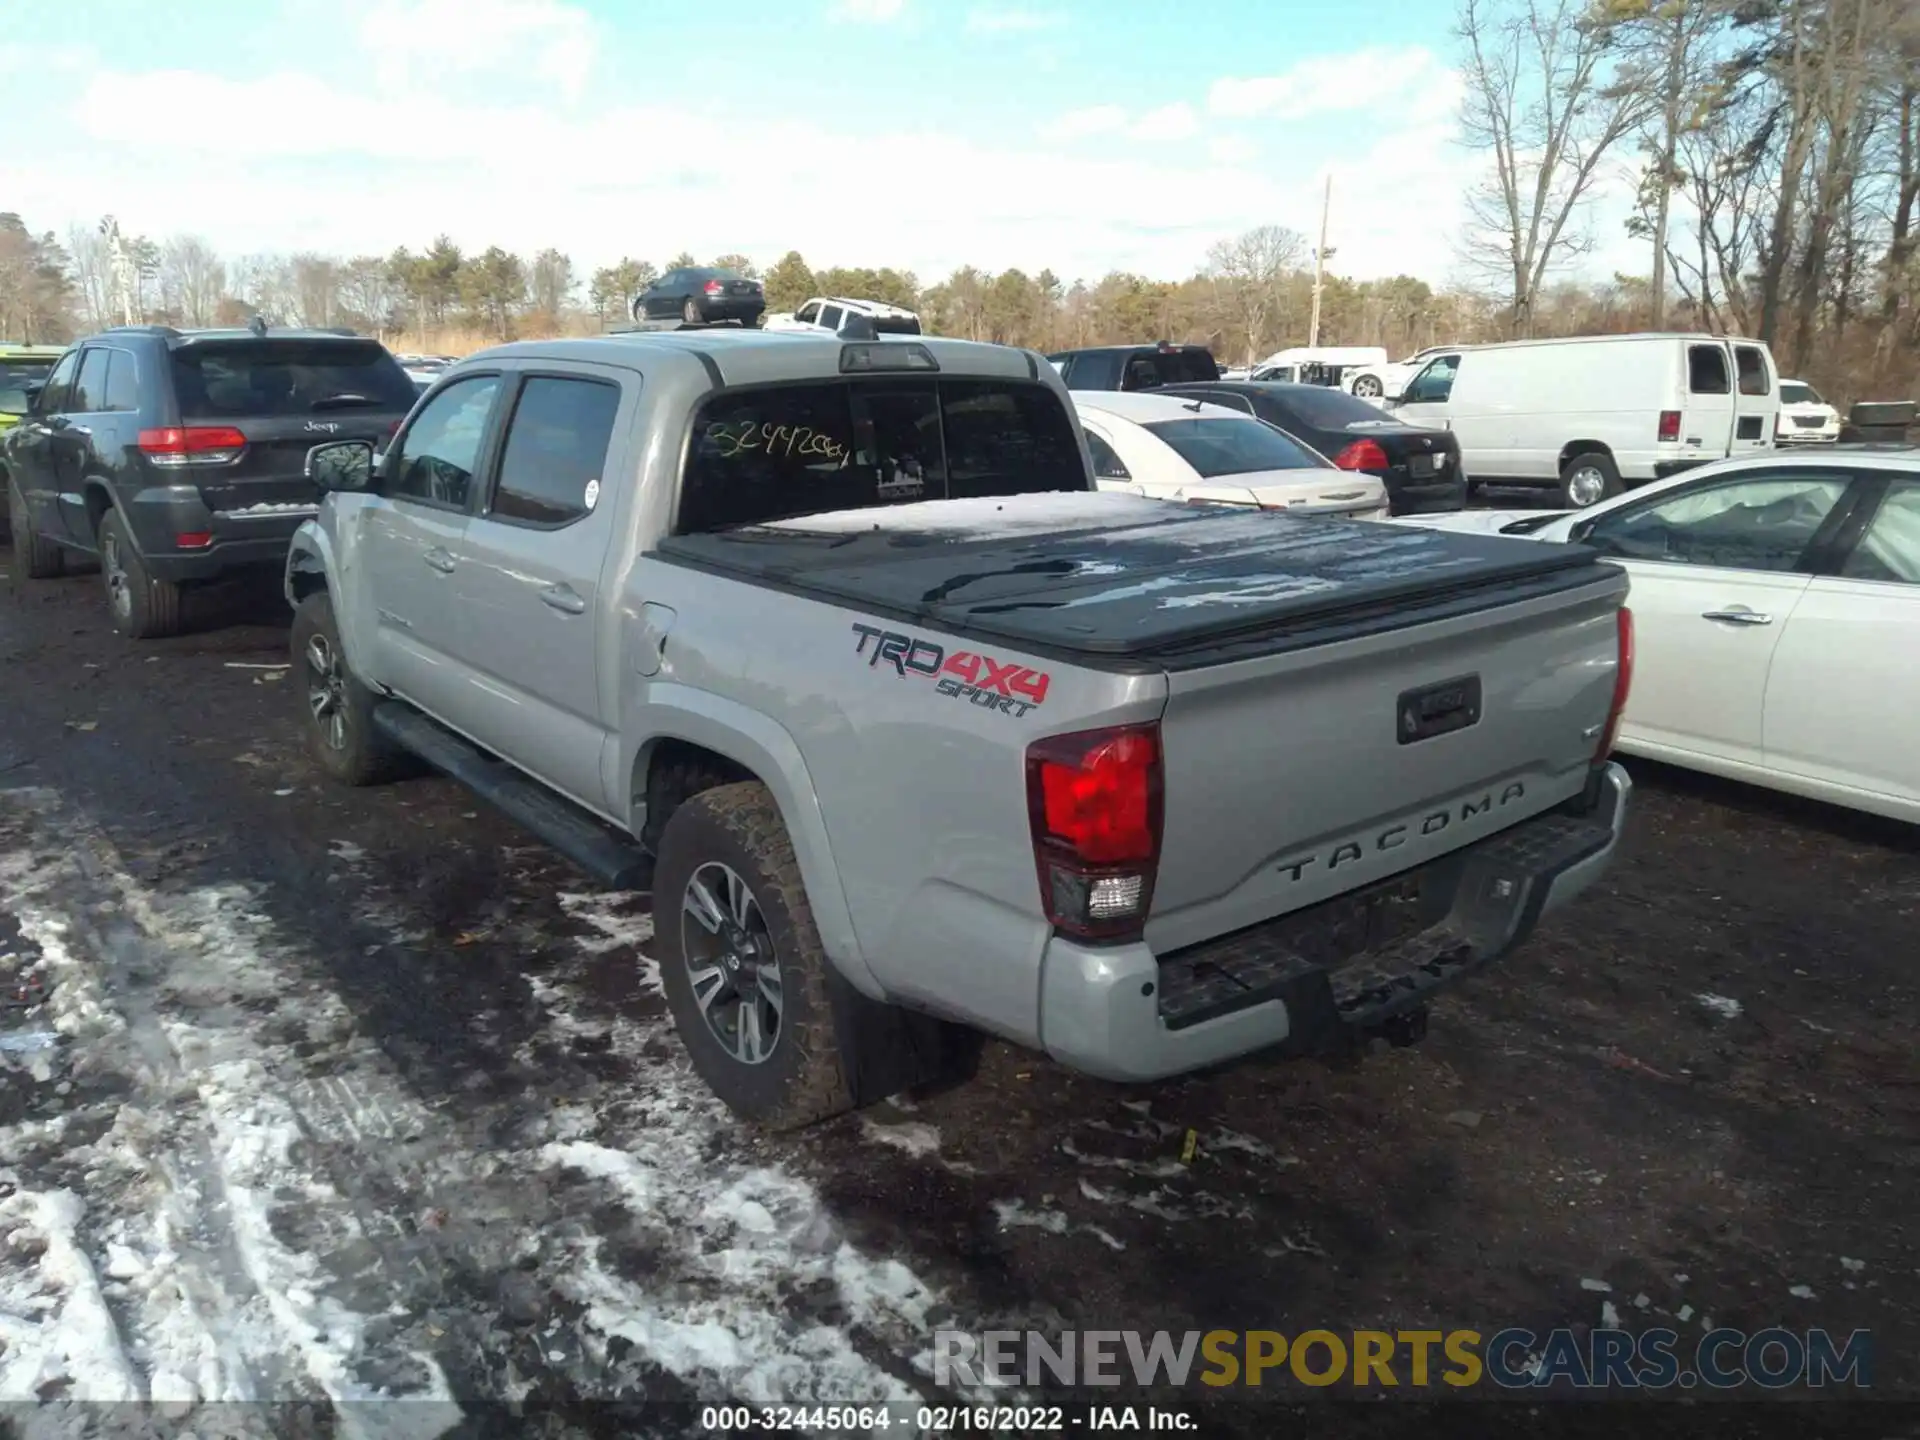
[490,374,620,526]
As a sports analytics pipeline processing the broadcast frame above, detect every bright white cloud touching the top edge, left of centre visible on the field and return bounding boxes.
[359,0,599,98]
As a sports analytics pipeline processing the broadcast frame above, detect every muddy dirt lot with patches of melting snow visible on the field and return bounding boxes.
[0,549,1920,1436]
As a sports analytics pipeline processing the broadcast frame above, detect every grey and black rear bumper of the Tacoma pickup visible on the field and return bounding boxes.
[1041,764,1632,1081]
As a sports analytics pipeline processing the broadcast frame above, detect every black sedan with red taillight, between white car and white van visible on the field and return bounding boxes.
[1158,380,1467,515]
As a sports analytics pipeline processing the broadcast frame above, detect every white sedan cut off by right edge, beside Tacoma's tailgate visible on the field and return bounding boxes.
[1394,447,1920,824]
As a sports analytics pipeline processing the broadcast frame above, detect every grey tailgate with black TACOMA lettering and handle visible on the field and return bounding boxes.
[1146,566,1626,954]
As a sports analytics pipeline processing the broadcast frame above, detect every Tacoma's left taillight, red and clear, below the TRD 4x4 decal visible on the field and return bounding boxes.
[1027,724,1164,941]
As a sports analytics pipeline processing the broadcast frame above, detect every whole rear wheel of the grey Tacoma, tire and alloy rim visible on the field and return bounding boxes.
[653,781,852,1129]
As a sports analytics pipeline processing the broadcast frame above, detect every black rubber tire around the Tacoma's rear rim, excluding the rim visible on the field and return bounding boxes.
[653,781,852,1131]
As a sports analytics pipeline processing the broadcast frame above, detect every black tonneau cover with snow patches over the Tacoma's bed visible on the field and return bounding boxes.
[659,492,1617,668]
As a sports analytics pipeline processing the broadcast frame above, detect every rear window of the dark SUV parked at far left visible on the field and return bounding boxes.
[173,340,415,420]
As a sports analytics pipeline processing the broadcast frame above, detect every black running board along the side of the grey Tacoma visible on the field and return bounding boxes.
[372,701,653,891]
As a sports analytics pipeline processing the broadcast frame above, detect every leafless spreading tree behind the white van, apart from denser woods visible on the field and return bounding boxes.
[1455,0,1647,334]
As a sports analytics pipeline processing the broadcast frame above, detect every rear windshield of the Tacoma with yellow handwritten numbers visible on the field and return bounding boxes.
[674,380,1087,536]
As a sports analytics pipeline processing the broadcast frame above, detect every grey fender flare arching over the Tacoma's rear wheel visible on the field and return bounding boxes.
[620,684,887,1000]
